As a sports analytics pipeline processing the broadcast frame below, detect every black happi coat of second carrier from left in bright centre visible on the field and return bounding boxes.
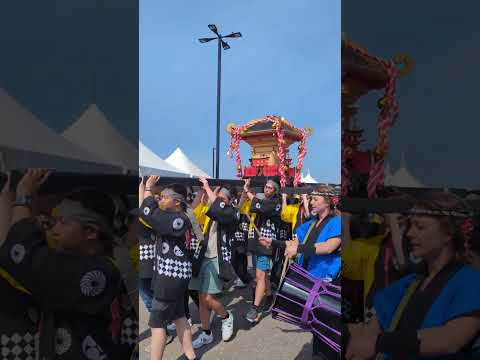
[201,198,240,281]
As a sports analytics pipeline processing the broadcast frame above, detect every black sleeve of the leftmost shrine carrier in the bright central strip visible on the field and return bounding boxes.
[140,196,189,238]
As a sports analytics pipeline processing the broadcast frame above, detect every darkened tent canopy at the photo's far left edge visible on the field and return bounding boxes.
[0,88,120,172]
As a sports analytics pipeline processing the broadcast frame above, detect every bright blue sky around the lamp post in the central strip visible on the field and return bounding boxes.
[139,0,341,183]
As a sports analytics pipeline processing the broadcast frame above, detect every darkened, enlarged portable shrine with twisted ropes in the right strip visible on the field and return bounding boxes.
[341,36,413,198]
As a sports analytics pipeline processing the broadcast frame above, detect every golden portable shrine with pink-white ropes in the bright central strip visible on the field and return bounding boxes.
[227,115,313,188]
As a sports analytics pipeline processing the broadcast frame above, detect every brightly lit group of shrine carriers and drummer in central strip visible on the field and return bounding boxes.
[139,176,341,360]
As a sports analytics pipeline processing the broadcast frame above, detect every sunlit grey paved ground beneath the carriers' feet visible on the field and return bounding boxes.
[139,282,312,360]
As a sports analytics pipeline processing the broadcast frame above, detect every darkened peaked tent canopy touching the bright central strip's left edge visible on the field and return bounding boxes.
[62,104,138,171]
